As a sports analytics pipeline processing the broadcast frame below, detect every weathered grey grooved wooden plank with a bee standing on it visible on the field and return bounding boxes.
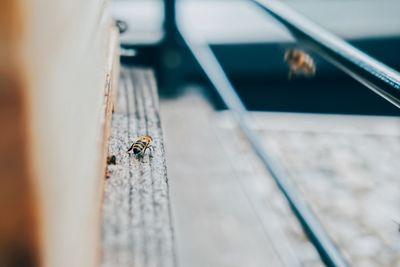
[102,68,176,267]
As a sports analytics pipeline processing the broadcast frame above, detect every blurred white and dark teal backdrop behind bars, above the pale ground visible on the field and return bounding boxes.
[113,0,400,115]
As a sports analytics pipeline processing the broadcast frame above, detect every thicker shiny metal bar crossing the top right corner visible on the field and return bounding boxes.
[251,0,400,108]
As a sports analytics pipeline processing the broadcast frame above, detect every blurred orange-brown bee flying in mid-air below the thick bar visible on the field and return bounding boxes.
[285,49,316,80]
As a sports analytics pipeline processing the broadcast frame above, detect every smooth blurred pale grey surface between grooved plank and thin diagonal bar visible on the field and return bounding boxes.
[161,91,323,267]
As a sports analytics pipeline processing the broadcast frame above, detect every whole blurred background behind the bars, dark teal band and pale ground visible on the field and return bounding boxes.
[112,0,400,267]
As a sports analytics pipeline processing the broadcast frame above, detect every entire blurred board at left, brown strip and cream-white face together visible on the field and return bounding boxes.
[0,0,119,267]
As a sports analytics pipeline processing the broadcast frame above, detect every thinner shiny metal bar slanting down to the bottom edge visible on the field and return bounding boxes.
[177,19,348,266]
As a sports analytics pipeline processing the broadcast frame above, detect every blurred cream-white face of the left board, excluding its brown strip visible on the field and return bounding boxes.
[13,0,115,267]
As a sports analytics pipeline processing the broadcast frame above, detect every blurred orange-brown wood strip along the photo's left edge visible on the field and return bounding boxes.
[0,0,41,267]
